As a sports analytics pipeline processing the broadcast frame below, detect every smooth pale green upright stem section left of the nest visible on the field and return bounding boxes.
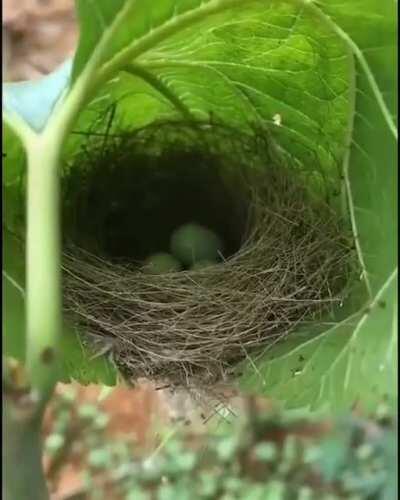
[26,133,62,400]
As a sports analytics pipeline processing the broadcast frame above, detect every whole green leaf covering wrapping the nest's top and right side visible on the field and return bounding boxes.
[6,0,397,408]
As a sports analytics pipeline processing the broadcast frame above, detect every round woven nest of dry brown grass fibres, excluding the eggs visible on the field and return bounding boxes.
[63,123,350,389]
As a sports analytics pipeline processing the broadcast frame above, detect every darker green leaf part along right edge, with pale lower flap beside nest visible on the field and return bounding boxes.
[241,1,397,408]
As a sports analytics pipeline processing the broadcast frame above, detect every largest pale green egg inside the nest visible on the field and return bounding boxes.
[170,223,223,266]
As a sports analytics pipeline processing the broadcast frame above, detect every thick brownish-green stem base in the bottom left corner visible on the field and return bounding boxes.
[2,395,49,500]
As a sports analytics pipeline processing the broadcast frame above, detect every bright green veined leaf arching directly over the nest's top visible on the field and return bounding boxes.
[74,0,353,174]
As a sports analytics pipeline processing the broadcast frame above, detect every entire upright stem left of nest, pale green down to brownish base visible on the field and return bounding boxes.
[3,113,63,500]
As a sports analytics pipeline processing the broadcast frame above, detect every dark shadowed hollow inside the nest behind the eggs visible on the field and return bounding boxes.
[64,146,247,262]
